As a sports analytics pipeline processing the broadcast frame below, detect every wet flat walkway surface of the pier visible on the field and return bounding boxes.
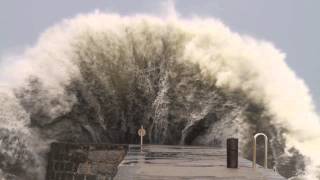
[114,145,285,180]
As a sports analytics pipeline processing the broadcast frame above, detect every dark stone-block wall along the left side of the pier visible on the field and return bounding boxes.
[46,142,128,180]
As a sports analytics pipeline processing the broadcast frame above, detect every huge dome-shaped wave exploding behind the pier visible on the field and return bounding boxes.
[0,13,320,180]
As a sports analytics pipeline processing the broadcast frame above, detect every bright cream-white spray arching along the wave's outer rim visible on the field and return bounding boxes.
[0,10,320,179]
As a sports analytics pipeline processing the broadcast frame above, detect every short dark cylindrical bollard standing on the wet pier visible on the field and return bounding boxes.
[227,138,238,168]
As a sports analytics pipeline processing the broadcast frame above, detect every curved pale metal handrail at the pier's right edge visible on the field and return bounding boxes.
[252,133,268,169]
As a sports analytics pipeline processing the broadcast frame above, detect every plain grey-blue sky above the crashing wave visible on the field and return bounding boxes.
[0,0,320,112]
